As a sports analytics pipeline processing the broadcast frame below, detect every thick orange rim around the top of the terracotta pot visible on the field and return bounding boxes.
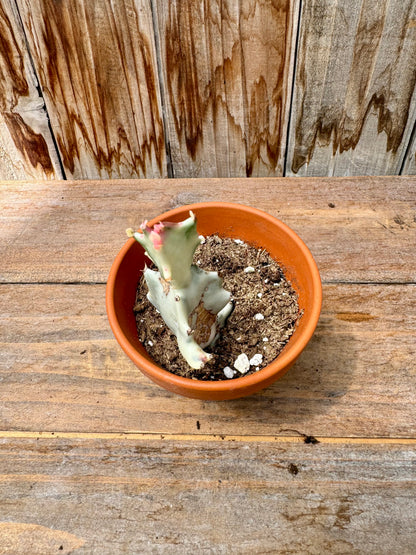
[106,201,322,392]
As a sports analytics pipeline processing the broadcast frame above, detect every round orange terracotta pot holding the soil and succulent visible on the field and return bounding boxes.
[106,202,322,400]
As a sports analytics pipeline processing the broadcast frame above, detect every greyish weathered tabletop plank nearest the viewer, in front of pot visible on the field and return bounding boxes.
[0,439,416,555]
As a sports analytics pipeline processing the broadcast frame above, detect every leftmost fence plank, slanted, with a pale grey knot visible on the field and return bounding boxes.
[0,0,62,179]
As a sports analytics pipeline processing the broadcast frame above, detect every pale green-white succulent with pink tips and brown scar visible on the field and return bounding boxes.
[127,212,233,369]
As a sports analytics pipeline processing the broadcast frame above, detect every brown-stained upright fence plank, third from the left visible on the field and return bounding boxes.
[154,0,299,177]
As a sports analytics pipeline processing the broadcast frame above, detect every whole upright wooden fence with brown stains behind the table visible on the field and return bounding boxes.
[0,0,416,179]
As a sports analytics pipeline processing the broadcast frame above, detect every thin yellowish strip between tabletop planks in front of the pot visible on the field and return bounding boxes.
[0,431,416,445]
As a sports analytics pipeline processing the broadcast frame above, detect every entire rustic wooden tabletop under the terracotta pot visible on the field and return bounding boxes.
[0,177,416,555]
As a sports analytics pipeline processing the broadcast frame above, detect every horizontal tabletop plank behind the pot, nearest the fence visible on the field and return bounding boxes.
[0,177,416,283]
